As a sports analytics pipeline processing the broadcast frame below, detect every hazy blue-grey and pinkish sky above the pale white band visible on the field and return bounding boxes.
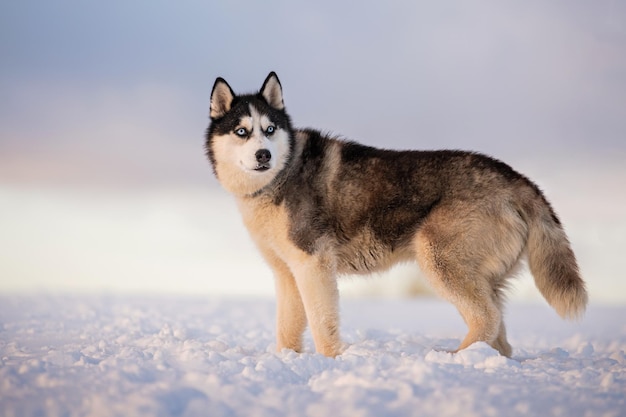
[0,0,626,188]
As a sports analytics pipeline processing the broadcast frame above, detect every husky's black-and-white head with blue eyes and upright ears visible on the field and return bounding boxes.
[206,72,293,196]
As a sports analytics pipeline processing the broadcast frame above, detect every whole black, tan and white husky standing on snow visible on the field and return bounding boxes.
[206,72,587,357]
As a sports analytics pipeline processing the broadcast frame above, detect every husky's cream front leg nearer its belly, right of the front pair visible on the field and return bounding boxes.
[293,260,341,357]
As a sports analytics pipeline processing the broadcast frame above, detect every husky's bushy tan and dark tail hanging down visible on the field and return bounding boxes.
[528,201,588,319]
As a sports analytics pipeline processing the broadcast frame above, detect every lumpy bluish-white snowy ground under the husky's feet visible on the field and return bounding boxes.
[0,295,626,417]
